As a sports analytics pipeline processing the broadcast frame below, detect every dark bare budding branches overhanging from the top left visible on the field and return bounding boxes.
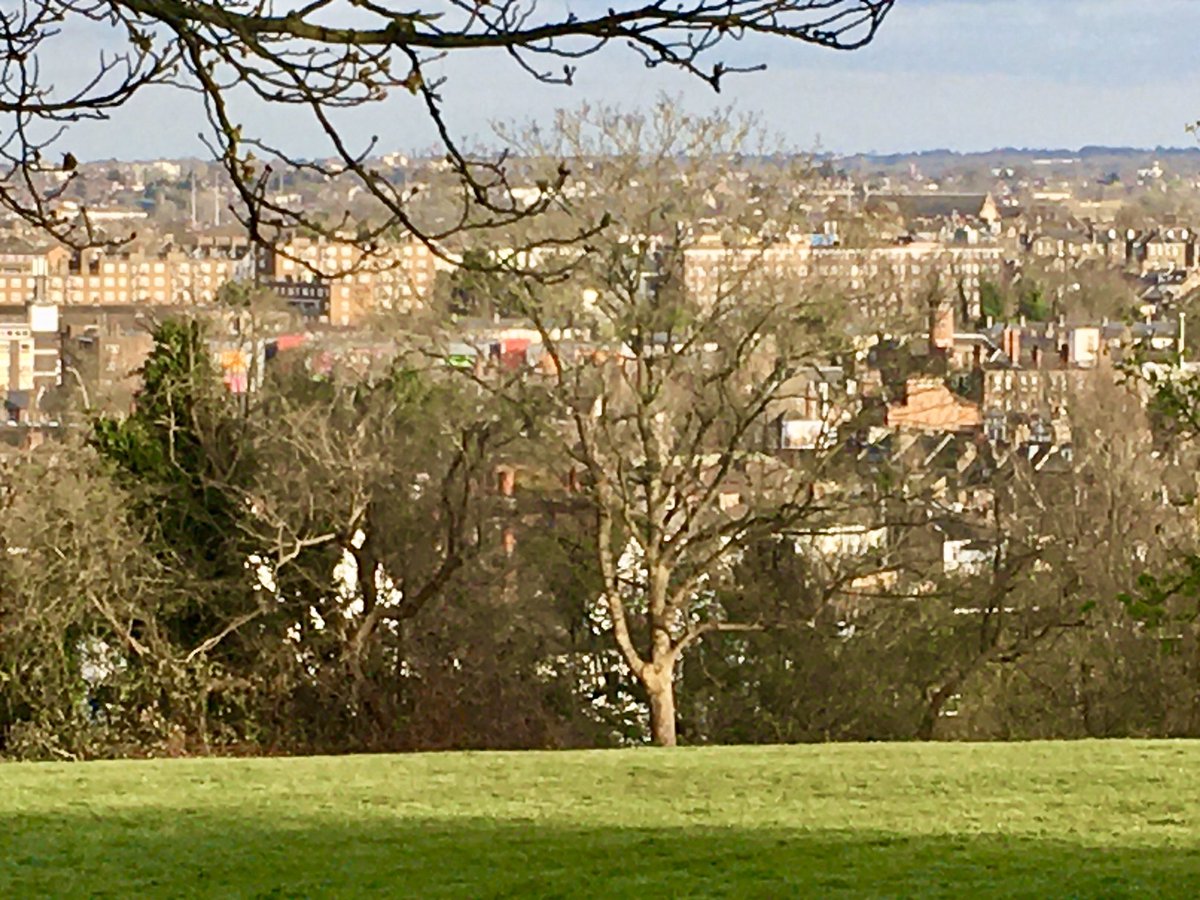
[0,0,894,252]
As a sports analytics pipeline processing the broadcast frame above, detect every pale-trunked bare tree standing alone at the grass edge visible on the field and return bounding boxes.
[482,103,888,745]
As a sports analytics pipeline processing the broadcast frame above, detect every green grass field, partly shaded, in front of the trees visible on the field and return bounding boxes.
[0,742,1200,898]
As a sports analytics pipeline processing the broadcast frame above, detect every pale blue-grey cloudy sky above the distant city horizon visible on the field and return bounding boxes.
[58,0,1200,158]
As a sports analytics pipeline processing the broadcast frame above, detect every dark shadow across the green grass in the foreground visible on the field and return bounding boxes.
[0,810,1200,898]
